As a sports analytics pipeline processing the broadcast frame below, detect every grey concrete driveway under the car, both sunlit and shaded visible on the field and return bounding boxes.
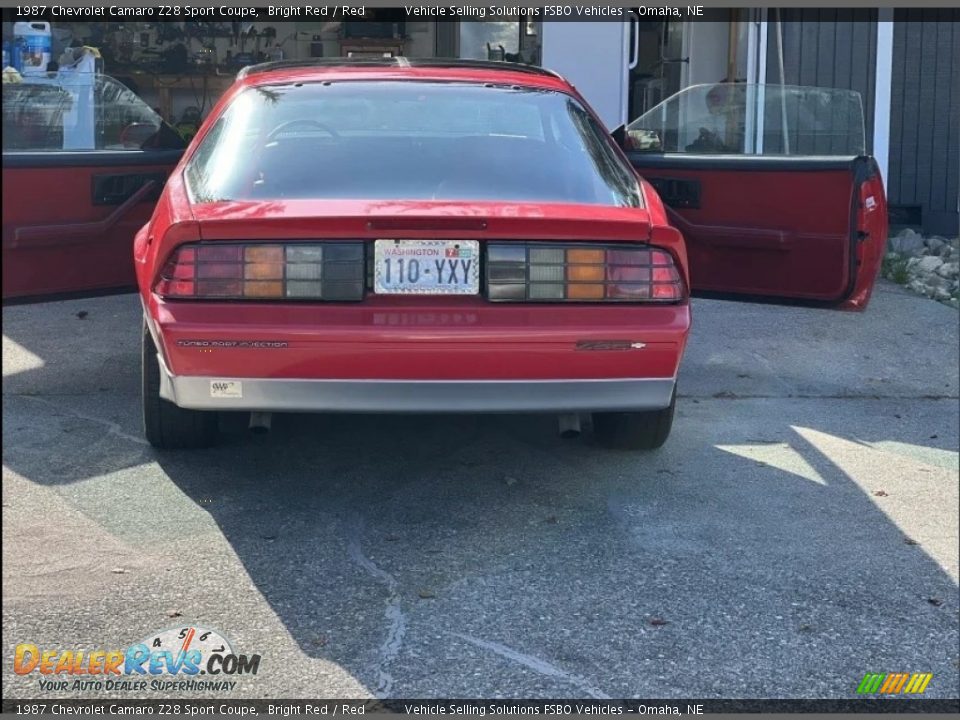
[2,284,960,698]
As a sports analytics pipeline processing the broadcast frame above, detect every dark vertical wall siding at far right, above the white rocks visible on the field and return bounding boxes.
[887,8,960,236]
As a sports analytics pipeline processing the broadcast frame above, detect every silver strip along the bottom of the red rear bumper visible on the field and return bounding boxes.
[158,357,675,413]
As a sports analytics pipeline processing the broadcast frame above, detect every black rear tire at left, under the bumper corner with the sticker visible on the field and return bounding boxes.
[140,322,218,450]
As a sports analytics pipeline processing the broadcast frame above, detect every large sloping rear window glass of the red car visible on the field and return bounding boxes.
[187,81,641,207]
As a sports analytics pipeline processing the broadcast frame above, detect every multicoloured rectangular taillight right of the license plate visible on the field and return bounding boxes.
[487,243,686,302]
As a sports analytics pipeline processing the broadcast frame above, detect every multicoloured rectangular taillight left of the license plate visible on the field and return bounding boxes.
[155,242,364,301]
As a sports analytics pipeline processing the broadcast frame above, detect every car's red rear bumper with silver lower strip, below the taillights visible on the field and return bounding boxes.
[145,296,690,413]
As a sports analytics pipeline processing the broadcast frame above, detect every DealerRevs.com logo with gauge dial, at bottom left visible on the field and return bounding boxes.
[13,626,260,692]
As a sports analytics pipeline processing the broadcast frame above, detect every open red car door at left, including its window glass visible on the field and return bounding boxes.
[3,71,185,302]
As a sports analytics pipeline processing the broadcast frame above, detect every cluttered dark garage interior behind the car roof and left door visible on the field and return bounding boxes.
[3,17,541,129]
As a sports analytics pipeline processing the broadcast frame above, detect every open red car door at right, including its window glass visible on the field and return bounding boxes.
[618,83,887,310]
